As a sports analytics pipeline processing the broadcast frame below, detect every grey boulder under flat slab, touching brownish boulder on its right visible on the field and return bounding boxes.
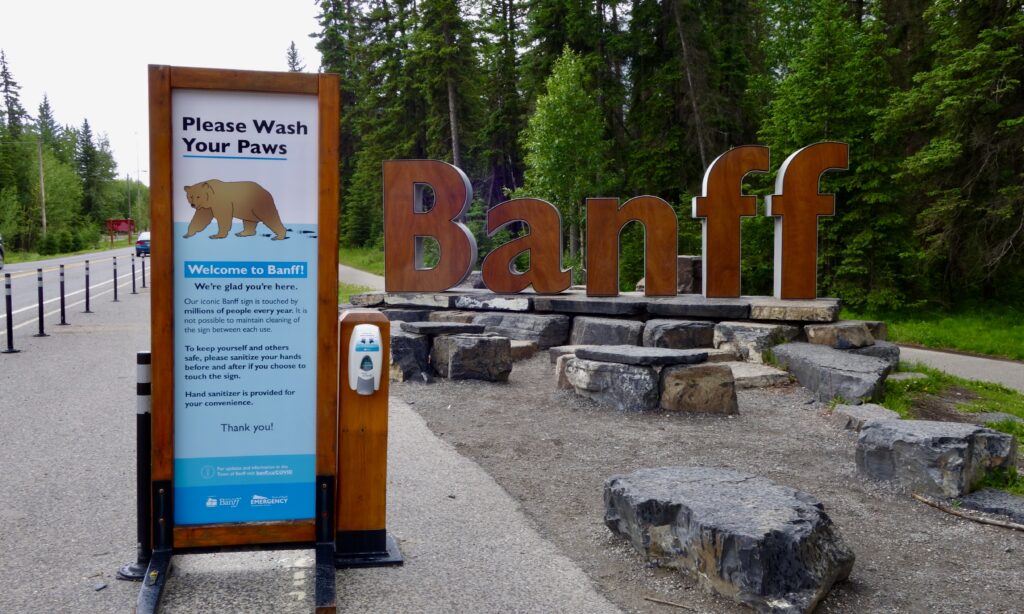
[565,358,657,411]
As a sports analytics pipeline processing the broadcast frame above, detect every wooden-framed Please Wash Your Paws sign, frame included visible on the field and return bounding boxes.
[150,65,339,552]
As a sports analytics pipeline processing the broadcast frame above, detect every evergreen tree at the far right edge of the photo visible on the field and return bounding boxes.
[885,0,1024,301]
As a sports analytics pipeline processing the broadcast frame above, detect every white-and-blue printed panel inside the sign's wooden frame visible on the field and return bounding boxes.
[171,90,318,525]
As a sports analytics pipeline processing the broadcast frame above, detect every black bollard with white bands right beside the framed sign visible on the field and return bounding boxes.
[118,352,153,581]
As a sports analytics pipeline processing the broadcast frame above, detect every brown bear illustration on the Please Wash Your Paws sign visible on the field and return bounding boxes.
[184,179,288,240]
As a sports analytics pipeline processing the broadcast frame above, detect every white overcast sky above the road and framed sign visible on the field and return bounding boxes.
[0,0,321,184]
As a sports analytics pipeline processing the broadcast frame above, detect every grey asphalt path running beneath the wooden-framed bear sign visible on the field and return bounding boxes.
[0,260,617,613]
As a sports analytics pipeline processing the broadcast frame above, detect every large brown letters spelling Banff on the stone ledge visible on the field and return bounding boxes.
[384,142,849,299]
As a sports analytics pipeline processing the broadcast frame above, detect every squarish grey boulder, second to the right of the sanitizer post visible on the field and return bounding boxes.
[430,335,512,382]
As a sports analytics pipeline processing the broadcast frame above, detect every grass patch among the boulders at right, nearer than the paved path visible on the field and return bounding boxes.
[882,363,1024,437]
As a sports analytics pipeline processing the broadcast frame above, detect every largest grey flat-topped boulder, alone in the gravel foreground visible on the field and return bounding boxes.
[604,467,854,614]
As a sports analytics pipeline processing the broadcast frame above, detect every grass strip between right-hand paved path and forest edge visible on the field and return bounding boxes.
[843,305,1024,360]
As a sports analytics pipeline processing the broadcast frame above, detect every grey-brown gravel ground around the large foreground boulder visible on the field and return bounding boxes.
[391,352,1024,614]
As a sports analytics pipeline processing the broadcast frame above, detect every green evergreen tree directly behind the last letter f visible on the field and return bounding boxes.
[759,0,909,308]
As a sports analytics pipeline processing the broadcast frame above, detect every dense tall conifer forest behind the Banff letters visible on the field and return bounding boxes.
[319,0,1024,309]
